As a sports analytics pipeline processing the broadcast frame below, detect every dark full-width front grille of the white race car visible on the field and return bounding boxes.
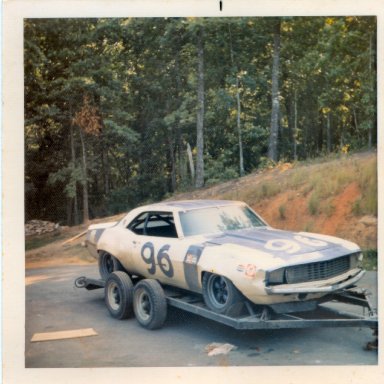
[285,255,350,284]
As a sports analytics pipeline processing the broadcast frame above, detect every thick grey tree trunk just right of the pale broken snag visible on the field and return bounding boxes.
[195,27,204,188]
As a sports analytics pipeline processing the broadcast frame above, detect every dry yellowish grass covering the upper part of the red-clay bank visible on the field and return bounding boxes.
[218,156,377,225]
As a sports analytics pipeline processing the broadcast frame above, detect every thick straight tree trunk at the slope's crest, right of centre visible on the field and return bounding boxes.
[268,20,280,161]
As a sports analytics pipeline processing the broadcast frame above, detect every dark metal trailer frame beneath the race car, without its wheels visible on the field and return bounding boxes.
[75,277,378,338]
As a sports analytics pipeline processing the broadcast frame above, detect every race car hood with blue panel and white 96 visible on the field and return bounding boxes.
[206,227,360,263]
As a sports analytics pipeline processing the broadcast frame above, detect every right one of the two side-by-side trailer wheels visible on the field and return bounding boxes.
[133,279,167,329]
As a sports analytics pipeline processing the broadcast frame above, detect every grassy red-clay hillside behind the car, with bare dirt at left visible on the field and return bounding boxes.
[26,152,377,267]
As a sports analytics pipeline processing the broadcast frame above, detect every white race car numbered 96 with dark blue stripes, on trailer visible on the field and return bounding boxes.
[86,200,364,314]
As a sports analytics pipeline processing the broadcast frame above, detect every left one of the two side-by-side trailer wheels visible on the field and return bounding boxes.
[104,271,133,320]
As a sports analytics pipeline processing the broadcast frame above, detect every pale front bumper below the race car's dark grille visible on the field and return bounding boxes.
[265,270,365,295]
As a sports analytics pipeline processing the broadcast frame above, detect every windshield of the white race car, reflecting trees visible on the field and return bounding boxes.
[179,205,266,236]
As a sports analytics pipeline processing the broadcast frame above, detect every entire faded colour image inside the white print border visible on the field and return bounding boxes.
[23,15,378,368]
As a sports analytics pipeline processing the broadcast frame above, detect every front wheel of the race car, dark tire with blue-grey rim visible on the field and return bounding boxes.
[202,273,243,316]
